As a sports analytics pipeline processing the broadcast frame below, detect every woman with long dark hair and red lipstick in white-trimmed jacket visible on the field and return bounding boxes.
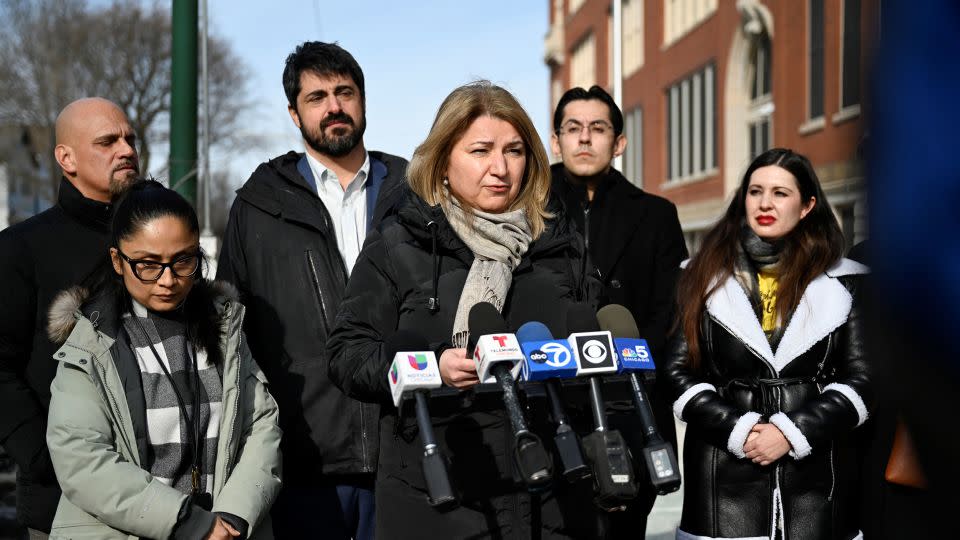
[666,148,873,540]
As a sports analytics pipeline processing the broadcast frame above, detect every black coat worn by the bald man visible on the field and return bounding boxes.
[0,179,110,531]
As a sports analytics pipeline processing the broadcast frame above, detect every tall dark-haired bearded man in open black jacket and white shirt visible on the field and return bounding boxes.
[217,41,407,540]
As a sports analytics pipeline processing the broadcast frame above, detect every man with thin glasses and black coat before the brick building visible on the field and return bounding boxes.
[550,86,687,538]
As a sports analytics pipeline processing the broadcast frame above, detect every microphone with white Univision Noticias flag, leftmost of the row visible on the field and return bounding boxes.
[385,330,458,509]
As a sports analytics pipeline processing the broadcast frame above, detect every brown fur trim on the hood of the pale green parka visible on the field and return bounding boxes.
[47,279,239,348]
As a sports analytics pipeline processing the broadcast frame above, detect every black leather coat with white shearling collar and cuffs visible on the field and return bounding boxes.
[666,259,874,540]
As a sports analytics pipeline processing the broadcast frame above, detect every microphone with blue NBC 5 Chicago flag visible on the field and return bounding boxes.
[597,304,680,495]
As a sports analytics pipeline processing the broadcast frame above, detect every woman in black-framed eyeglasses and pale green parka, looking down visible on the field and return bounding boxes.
[47,181,280,539]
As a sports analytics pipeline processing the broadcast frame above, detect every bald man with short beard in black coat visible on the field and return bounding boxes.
[0,98,139,539]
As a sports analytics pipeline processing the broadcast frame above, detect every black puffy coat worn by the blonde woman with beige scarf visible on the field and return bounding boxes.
[330,194,598,538]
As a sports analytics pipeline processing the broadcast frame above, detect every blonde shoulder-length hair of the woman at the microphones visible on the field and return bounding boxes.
[407,81,553,239]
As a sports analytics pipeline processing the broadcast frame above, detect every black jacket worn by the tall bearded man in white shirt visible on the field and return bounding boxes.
[217,152,406,478]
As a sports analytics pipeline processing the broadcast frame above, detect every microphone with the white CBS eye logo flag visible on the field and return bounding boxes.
[567,304,637,510]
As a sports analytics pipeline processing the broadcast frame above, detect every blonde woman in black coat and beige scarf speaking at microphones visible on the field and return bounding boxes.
[329,81,597,539]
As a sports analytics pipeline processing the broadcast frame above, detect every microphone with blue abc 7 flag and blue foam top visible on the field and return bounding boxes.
[517,321,591,483]
